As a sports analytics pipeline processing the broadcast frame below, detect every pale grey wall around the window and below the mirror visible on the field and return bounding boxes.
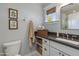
[43,4,79,35]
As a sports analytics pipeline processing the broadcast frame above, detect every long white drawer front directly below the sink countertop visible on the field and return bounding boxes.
[50,41,79,56]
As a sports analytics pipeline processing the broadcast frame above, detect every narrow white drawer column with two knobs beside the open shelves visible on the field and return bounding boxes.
[42,38,50,56]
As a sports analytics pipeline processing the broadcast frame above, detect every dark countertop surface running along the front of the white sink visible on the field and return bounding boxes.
[36,35,79,50]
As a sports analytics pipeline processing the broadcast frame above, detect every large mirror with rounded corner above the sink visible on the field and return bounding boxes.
[60,3,79,30]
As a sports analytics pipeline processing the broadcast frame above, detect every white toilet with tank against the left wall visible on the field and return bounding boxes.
[3,40,21,56]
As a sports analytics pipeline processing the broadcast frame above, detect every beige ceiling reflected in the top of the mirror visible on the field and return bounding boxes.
[61,3,79,14]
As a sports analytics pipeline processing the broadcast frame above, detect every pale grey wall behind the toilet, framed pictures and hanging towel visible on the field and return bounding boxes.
[0,3,43,55]
